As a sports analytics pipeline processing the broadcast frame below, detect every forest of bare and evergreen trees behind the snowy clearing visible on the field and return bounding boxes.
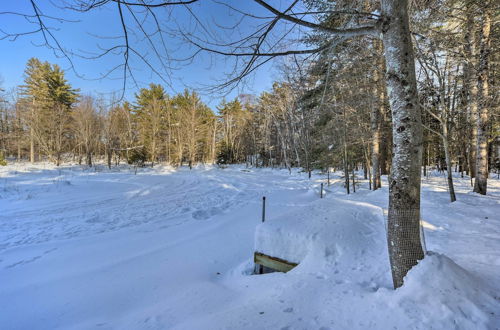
[0,1,500,195]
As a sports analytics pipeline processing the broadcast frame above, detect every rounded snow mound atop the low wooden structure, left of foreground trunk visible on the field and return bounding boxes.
[255,198,388,269]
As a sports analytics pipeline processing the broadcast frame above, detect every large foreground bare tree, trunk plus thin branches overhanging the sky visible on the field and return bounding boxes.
[3,0,424,287]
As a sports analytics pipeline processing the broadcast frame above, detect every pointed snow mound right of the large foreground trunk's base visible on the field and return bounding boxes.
[381,252,500,329]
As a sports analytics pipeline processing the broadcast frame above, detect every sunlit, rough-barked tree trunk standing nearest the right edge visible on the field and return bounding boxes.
[474,8,491,195]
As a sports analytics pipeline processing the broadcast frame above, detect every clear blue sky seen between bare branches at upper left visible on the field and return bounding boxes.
[0,0,292,108]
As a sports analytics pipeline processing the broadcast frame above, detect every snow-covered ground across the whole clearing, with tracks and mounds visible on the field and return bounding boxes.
[0,164,500,329]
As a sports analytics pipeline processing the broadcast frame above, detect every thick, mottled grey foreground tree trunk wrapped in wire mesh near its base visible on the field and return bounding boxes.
[382,0,424,288]
